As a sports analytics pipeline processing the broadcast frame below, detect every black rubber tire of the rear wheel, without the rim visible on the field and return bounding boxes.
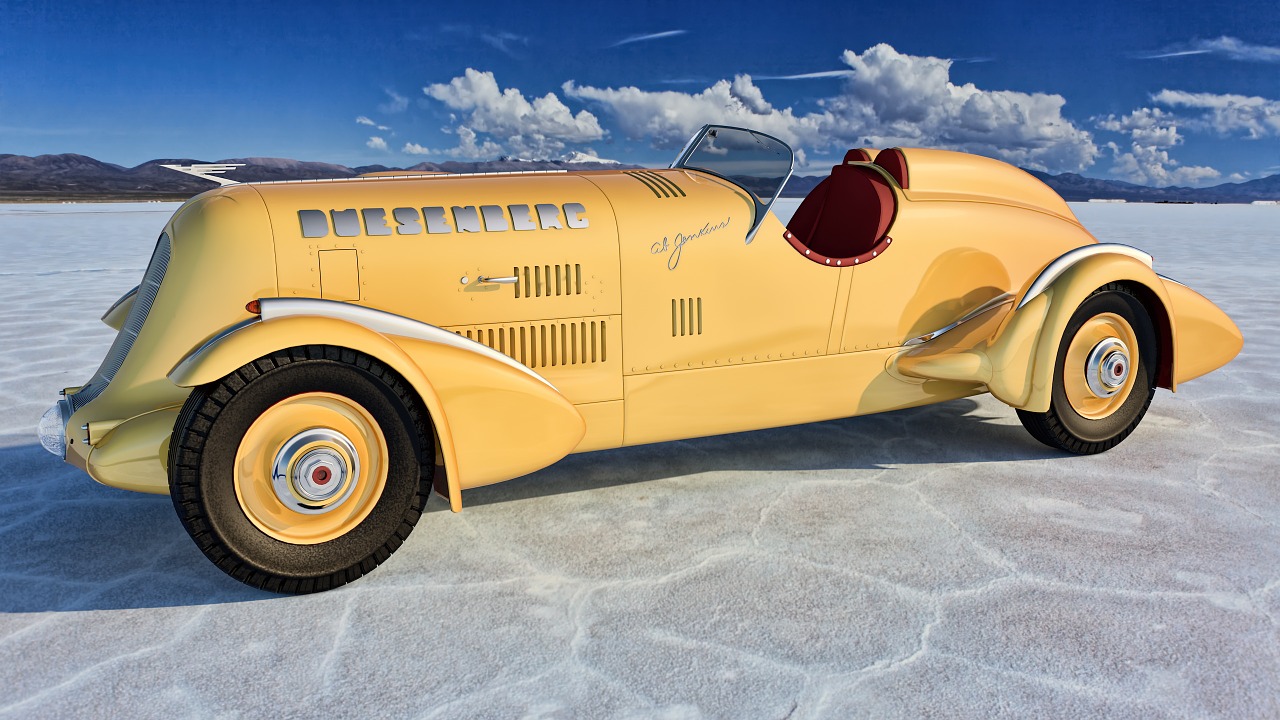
[1018,283,1160,455]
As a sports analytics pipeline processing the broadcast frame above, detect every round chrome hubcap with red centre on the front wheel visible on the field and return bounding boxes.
[271,428,360,515]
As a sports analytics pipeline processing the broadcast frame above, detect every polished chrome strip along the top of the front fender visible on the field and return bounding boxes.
[261,297,559,392]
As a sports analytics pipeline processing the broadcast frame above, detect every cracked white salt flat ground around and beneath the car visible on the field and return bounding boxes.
[0,202,1280,719]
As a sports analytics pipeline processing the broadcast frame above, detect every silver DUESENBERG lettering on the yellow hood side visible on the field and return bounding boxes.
[298,202,590,237]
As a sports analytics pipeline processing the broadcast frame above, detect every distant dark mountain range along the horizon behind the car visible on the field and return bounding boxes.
[0,154,1280,202]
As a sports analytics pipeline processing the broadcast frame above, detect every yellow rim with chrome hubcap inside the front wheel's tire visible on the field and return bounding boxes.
[234,392,388,544]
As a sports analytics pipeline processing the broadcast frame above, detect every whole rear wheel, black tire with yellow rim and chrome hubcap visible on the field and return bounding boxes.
[1018,283,1158,455]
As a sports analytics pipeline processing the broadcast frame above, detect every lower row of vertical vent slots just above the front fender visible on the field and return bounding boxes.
[453,320,609,369]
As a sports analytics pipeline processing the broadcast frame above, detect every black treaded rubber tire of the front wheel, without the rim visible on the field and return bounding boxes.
[169,345,435,593]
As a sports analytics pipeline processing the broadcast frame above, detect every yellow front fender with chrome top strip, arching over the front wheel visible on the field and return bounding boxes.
[169,299,586,511]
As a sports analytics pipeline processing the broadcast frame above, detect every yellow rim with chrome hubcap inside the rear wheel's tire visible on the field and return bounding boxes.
[1062,313,1139,420]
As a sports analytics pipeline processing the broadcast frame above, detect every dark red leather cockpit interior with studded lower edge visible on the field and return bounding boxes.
[787,165,897,265]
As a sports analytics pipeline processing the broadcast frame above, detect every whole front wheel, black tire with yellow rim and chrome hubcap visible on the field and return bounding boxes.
[169,346,434,593]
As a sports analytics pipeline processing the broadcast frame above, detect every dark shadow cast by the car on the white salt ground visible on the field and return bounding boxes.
[0,400,1059,612]
